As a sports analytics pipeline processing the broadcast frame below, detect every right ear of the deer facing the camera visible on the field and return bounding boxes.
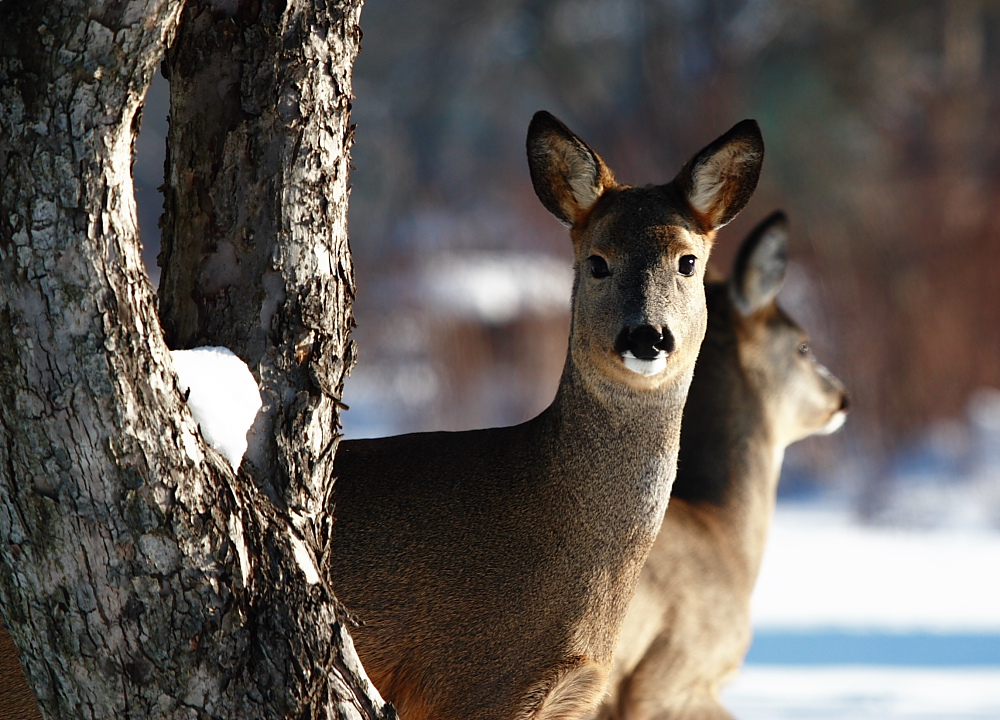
[674,120,764,230]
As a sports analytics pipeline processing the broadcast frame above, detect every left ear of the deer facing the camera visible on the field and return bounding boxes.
[527,110,615,225]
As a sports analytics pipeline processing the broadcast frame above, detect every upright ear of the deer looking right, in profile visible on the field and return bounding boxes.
[729,210,788,316]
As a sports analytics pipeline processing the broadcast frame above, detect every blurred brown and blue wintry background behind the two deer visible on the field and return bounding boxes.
[135,0,1000,719]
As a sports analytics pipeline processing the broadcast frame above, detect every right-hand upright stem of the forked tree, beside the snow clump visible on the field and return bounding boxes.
[160,0,361,506]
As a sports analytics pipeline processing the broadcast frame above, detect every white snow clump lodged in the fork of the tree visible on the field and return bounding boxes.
[170,347,261,470]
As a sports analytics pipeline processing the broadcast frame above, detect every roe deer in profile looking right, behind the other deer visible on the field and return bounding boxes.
[602,212,848,720]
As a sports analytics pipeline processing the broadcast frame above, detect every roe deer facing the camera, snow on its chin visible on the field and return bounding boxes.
[326,112,763,720]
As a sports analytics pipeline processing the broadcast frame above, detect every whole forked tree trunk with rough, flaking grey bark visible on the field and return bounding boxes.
[0,0,392,718]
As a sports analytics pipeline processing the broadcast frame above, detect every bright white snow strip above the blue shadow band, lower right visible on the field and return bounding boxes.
[752,505,1000,632]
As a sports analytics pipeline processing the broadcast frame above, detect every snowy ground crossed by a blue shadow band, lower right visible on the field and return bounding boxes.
[723,505,1000,720]
